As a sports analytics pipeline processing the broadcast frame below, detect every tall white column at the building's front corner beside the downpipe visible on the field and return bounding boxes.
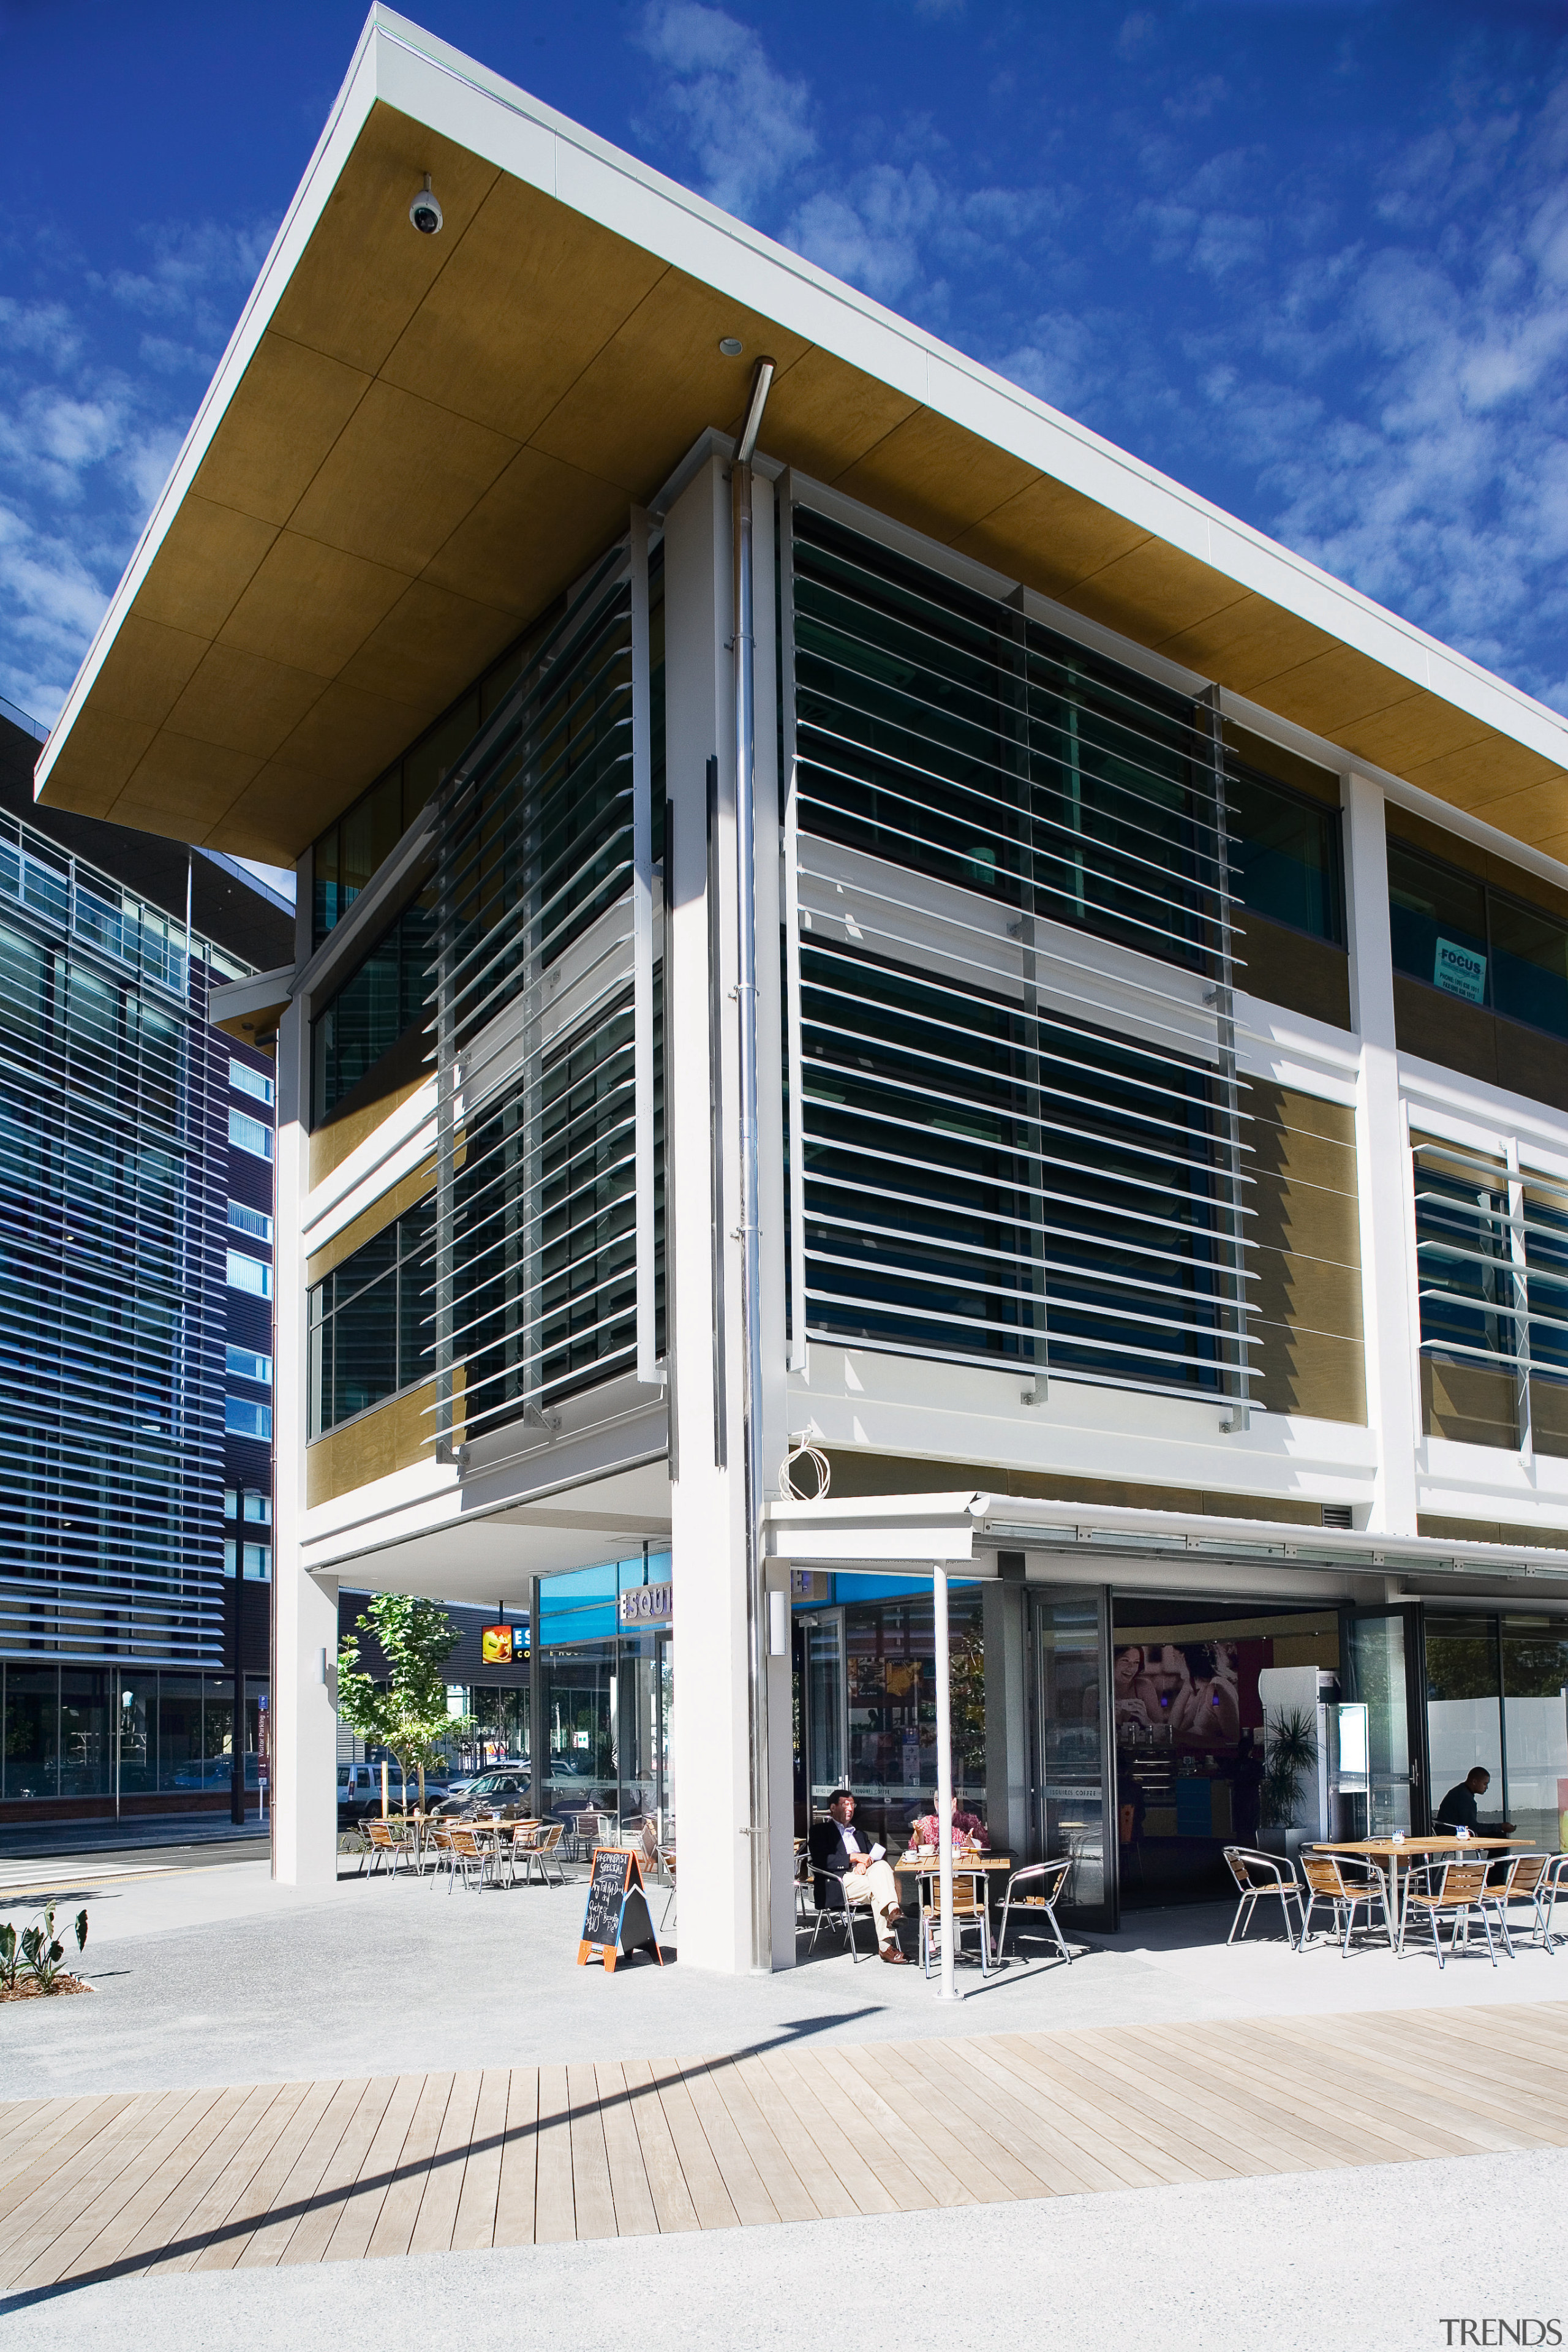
[665,461,752,1973]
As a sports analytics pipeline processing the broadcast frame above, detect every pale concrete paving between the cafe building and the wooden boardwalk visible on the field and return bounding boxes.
[0,1858,1568,2098]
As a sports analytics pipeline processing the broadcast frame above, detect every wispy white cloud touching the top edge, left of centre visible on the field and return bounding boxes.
[639,0,816,219]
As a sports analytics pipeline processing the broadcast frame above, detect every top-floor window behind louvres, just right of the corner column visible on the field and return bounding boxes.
[794,506,1220,964]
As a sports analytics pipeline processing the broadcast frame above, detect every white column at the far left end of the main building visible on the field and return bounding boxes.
[273,1005,339,1887]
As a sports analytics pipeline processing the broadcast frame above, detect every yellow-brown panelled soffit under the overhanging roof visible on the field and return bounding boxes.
[42,53,1568,863]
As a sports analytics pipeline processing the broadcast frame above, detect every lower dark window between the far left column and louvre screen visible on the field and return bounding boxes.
[308,1197,435,1437]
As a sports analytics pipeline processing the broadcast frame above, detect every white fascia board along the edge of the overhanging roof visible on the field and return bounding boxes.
[36,7,1568,809]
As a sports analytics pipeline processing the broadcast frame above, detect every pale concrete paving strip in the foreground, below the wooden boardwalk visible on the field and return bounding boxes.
[12,2150,1568,2352]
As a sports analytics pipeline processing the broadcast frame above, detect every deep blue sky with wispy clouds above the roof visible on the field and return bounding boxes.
[0,0,1568,720]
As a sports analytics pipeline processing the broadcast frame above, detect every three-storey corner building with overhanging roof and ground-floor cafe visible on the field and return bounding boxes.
[28,9,1568,1969]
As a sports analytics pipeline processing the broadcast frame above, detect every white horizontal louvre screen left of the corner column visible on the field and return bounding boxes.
[430,546,654,1453]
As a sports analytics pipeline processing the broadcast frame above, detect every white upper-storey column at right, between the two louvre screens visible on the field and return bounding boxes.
[1344,776,1420,1536]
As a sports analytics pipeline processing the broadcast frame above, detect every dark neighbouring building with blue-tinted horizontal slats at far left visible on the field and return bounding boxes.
[0,696,280,1820]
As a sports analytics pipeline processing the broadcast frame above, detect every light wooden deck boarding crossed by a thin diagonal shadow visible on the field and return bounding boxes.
[0,2002,1568,2293]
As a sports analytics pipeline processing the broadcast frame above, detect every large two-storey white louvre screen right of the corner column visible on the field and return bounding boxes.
[788,506,1257,1425]
